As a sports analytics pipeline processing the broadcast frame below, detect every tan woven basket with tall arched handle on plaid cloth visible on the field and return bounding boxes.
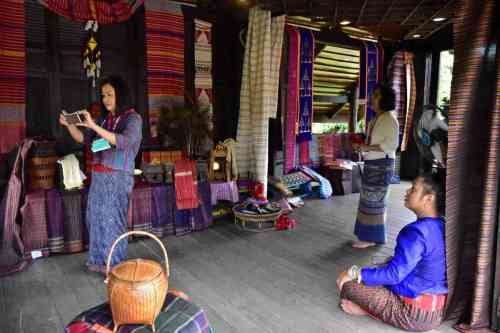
[106,231,170,332]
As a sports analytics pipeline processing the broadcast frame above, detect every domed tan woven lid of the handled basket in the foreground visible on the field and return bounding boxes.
[111,259,163,282]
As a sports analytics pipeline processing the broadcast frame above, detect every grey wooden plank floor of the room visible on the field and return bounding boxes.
[0,183,455,333]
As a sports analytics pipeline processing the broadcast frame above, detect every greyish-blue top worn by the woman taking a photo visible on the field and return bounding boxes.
[83,110,142,174]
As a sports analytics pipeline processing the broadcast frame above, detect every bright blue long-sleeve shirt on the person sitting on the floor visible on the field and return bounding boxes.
[361,217,448,298]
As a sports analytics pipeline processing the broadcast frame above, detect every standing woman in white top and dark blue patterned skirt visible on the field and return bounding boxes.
[352,84,399,248]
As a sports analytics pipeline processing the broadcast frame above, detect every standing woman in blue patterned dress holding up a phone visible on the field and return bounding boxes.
[59,76,142,273]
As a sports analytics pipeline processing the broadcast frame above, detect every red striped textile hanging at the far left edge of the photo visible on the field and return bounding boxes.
[0,0,26,154]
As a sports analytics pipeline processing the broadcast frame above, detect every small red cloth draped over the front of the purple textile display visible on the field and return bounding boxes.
[175,160,199,209]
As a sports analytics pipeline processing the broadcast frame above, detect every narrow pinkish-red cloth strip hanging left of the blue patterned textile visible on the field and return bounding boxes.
[285,26,300,173]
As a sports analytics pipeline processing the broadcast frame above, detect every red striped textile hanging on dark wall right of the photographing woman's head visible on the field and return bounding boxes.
[144,0,184,138]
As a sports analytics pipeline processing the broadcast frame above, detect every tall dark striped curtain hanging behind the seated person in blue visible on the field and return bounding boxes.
[446,0,500,332]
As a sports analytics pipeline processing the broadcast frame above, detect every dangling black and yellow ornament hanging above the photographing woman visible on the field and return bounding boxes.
[83,20,101,87]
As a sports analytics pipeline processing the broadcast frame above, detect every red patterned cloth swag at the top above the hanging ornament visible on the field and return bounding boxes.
[38,0,144,24]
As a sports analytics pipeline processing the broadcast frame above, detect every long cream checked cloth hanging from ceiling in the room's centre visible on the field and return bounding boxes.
[236,7,285,196]
